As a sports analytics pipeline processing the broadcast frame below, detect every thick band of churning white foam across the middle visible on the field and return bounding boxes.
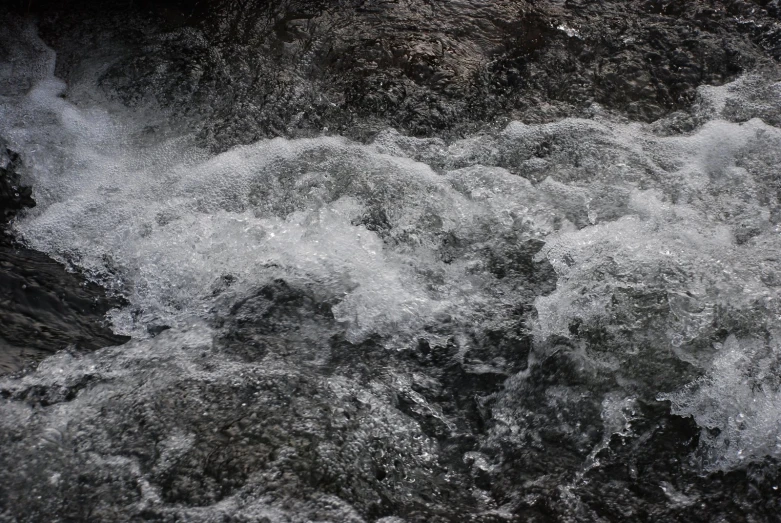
[0,20,781,468]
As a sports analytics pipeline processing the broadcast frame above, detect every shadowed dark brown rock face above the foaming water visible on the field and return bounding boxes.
[16,0,781,150]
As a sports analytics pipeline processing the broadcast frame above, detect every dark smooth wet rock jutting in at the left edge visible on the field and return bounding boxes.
[0,143,129,374]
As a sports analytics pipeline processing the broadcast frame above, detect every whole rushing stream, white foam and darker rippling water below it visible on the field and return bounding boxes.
[0,18,781,523]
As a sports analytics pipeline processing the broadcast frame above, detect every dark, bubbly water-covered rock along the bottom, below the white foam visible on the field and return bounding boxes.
[0,281,781,523]
